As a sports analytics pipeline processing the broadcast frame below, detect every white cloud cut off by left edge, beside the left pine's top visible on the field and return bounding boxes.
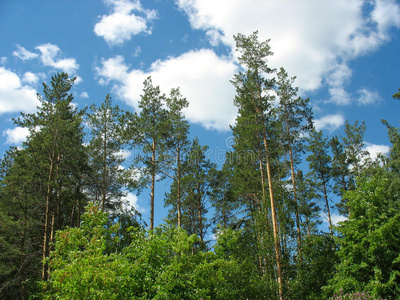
[0,67,40,113]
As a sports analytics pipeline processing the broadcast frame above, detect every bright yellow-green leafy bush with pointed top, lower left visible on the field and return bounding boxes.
[42,205,135,299]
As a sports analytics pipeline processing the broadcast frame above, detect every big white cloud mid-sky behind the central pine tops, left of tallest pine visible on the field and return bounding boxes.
[96,49,237,131]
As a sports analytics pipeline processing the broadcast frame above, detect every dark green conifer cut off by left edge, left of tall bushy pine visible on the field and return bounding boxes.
[0,148,44,299]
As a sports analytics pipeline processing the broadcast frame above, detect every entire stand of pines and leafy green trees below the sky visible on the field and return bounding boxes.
[0,32,400,300]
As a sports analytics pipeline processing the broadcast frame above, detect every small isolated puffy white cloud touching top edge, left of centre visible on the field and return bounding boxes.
[94,0,157,45]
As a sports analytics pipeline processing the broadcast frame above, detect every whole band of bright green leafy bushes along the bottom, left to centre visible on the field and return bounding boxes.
[36,204,273,300]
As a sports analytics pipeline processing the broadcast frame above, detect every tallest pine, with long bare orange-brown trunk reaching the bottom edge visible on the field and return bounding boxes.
[232,32,283,299]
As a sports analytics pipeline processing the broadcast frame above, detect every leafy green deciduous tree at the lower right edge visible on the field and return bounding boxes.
[329,170,400,299]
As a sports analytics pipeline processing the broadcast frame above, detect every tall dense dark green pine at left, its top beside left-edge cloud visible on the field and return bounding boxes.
[7,73,87,280]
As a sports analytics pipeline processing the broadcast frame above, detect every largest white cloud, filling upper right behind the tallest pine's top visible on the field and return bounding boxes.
[176,0,400,92]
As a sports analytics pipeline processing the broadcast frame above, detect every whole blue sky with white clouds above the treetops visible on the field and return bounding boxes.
[0,0,400,230]
